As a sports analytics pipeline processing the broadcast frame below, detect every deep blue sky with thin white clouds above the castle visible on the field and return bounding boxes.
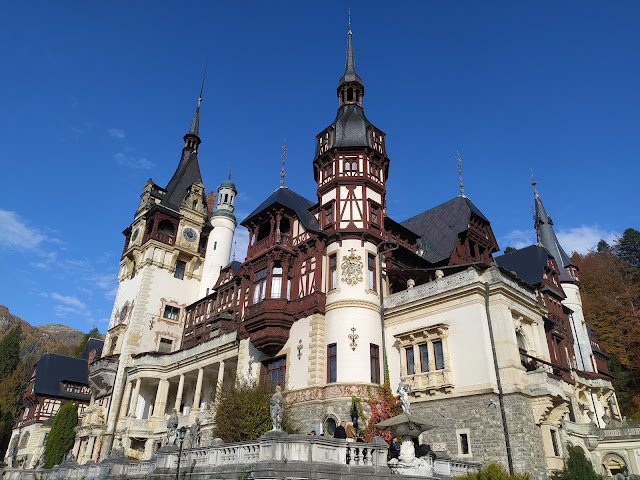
[0,1,640,331]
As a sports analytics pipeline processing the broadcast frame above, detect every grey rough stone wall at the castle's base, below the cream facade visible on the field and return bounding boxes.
[411,394,548,480]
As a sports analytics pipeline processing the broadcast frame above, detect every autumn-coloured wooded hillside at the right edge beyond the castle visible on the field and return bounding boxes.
[571,228,640,420]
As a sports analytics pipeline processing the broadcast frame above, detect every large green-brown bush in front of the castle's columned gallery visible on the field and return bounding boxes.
[213,380,294,442]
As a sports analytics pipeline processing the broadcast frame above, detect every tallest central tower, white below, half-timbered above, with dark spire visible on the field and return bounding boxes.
[313,25,389,384]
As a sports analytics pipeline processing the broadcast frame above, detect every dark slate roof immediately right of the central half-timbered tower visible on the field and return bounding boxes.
[400,196,489,263]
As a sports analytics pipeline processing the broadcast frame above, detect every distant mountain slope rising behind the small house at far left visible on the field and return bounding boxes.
[0,305,84,363]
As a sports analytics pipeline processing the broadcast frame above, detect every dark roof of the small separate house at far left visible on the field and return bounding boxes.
[33,353,88,399]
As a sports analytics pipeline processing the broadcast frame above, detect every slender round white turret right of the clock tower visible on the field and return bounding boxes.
[198,173,238,298]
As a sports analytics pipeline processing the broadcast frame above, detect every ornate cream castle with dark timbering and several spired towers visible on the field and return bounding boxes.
[11,20,640,479]
